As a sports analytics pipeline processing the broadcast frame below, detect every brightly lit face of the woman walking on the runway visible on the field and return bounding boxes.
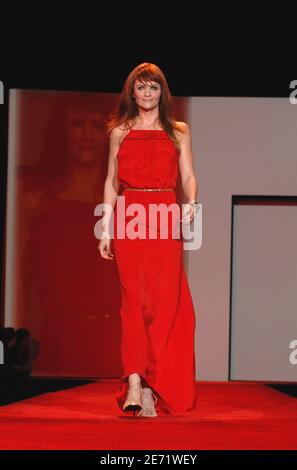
[133,79,162,111]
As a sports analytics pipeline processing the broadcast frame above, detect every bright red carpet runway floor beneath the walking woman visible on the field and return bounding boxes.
[0,380,297,450]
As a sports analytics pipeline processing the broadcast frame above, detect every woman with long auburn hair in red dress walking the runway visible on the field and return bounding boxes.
[99,63,198,417]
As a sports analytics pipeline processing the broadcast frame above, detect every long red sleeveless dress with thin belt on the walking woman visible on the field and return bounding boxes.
[113,129,196,413]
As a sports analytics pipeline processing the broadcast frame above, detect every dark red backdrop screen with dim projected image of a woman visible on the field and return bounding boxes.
[13,92,121,377]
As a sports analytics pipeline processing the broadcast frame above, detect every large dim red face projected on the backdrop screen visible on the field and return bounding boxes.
[66,110,106,163]
